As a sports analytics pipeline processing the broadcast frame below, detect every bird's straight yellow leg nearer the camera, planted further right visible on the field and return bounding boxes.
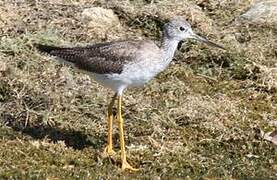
[117,96,138,171]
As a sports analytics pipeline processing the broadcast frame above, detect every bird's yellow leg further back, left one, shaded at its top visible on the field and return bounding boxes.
[104,94,116,156]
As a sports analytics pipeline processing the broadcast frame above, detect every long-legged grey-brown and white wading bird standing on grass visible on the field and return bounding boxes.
[36,18,223,170]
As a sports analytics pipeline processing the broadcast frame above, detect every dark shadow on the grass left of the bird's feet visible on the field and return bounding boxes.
[1,114,104,150]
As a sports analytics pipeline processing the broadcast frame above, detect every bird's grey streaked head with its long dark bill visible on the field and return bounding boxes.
[163,17,224,49]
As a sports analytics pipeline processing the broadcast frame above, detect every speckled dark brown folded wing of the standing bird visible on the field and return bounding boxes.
[35,41,141,74]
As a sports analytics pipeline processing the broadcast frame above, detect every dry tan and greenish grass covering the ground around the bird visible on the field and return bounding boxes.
[0,0,277,179]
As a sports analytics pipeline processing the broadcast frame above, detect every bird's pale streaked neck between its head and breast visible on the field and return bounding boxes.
[161,37,179,64]
